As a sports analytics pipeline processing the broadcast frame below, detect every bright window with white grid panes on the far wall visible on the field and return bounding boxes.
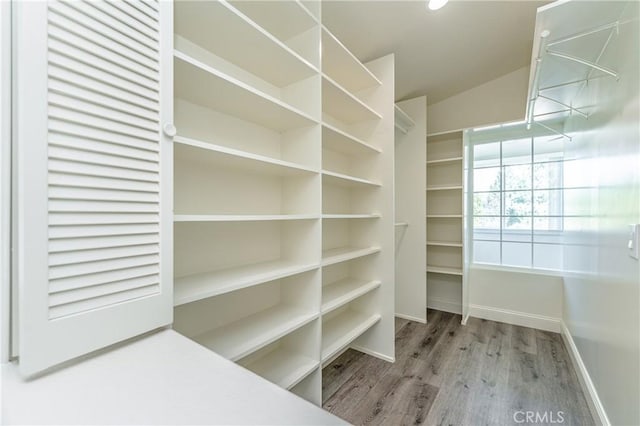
[470,129,565,270]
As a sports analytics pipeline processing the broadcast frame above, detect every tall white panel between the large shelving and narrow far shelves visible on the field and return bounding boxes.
[395,96,427,322]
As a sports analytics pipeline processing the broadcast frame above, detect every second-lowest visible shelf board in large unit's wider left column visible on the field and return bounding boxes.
[193,305,318,361]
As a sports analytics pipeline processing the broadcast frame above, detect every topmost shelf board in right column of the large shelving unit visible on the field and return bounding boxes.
[322,27,382,93]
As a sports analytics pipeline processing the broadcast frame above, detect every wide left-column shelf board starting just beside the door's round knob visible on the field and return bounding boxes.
[173,136,319,176]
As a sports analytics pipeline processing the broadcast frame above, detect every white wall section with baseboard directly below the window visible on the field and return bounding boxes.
[467,266,562,332]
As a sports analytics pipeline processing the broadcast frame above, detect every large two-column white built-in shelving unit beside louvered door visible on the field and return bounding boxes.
[173,1,394,404]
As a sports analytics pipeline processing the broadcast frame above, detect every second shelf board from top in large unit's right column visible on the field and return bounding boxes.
[322,75,382,124]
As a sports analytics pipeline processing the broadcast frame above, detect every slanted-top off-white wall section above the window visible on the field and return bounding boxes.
[427,66,529,134]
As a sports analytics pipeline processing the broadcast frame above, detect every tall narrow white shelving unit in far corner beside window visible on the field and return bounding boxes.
[426,132,464,311]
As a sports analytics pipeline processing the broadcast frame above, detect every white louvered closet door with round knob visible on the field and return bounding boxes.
[14,0,173,375]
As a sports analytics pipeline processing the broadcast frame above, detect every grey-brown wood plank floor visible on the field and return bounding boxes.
[323,310,594,426]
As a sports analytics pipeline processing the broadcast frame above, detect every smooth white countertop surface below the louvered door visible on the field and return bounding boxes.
[1,330,346,425]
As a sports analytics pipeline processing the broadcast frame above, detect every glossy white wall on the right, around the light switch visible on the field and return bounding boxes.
[564,2,640,425]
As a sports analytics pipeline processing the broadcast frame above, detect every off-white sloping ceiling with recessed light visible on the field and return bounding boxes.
[322,0,549,104]
